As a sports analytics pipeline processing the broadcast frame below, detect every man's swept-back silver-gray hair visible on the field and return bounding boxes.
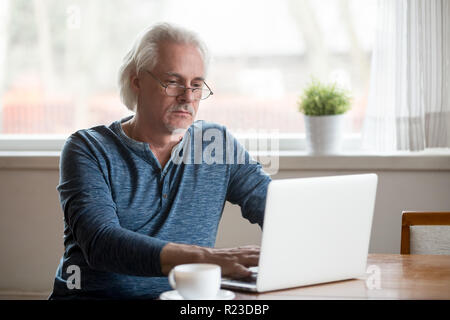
[119,23,209,111]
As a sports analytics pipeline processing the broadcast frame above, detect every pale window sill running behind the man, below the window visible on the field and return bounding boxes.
[0,150,450,171]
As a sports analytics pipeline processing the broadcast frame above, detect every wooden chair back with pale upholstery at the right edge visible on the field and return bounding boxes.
[400,211,450,254]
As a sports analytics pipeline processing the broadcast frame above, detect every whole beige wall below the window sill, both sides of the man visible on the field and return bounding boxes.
[0,156,450,294]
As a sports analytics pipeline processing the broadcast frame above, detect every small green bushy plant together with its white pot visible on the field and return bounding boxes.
[298,79,351,155]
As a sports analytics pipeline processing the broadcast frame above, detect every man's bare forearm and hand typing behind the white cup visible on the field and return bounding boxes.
[161,243,260,278]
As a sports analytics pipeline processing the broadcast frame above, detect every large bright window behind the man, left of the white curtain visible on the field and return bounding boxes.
[0,0,376,134]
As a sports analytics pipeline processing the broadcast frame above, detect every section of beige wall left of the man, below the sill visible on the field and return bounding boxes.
[0,170,63,292]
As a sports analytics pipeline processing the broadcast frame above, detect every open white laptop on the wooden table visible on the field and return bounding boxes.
[222,173,378,292]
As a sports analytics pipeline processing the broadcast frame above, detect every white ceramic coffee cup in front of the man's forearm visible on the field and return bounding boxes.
[169,263,222,300]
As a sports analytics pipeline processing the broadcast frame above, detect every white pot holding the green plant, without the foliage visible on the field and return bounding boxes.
[304,114,345,155]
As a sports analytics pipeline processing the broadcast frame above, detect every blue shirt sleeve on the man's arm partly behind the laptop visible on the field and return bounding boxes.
[226,132,271,228]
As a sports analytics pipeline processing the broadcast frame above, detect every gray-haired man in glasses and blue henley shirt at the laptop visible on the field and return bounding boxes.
[50,24,270,299]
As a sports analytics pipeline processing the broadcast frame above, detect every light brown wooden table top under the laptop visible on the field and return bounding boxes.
[235,254,450,300]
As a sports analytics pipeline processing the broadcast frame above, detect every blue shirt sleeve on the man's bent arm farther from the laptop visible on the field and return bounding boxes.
[57,134,167,276]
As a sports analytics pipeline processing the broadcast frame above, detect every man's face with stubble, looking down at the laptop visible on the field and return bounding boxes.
[137,42,204,133]
